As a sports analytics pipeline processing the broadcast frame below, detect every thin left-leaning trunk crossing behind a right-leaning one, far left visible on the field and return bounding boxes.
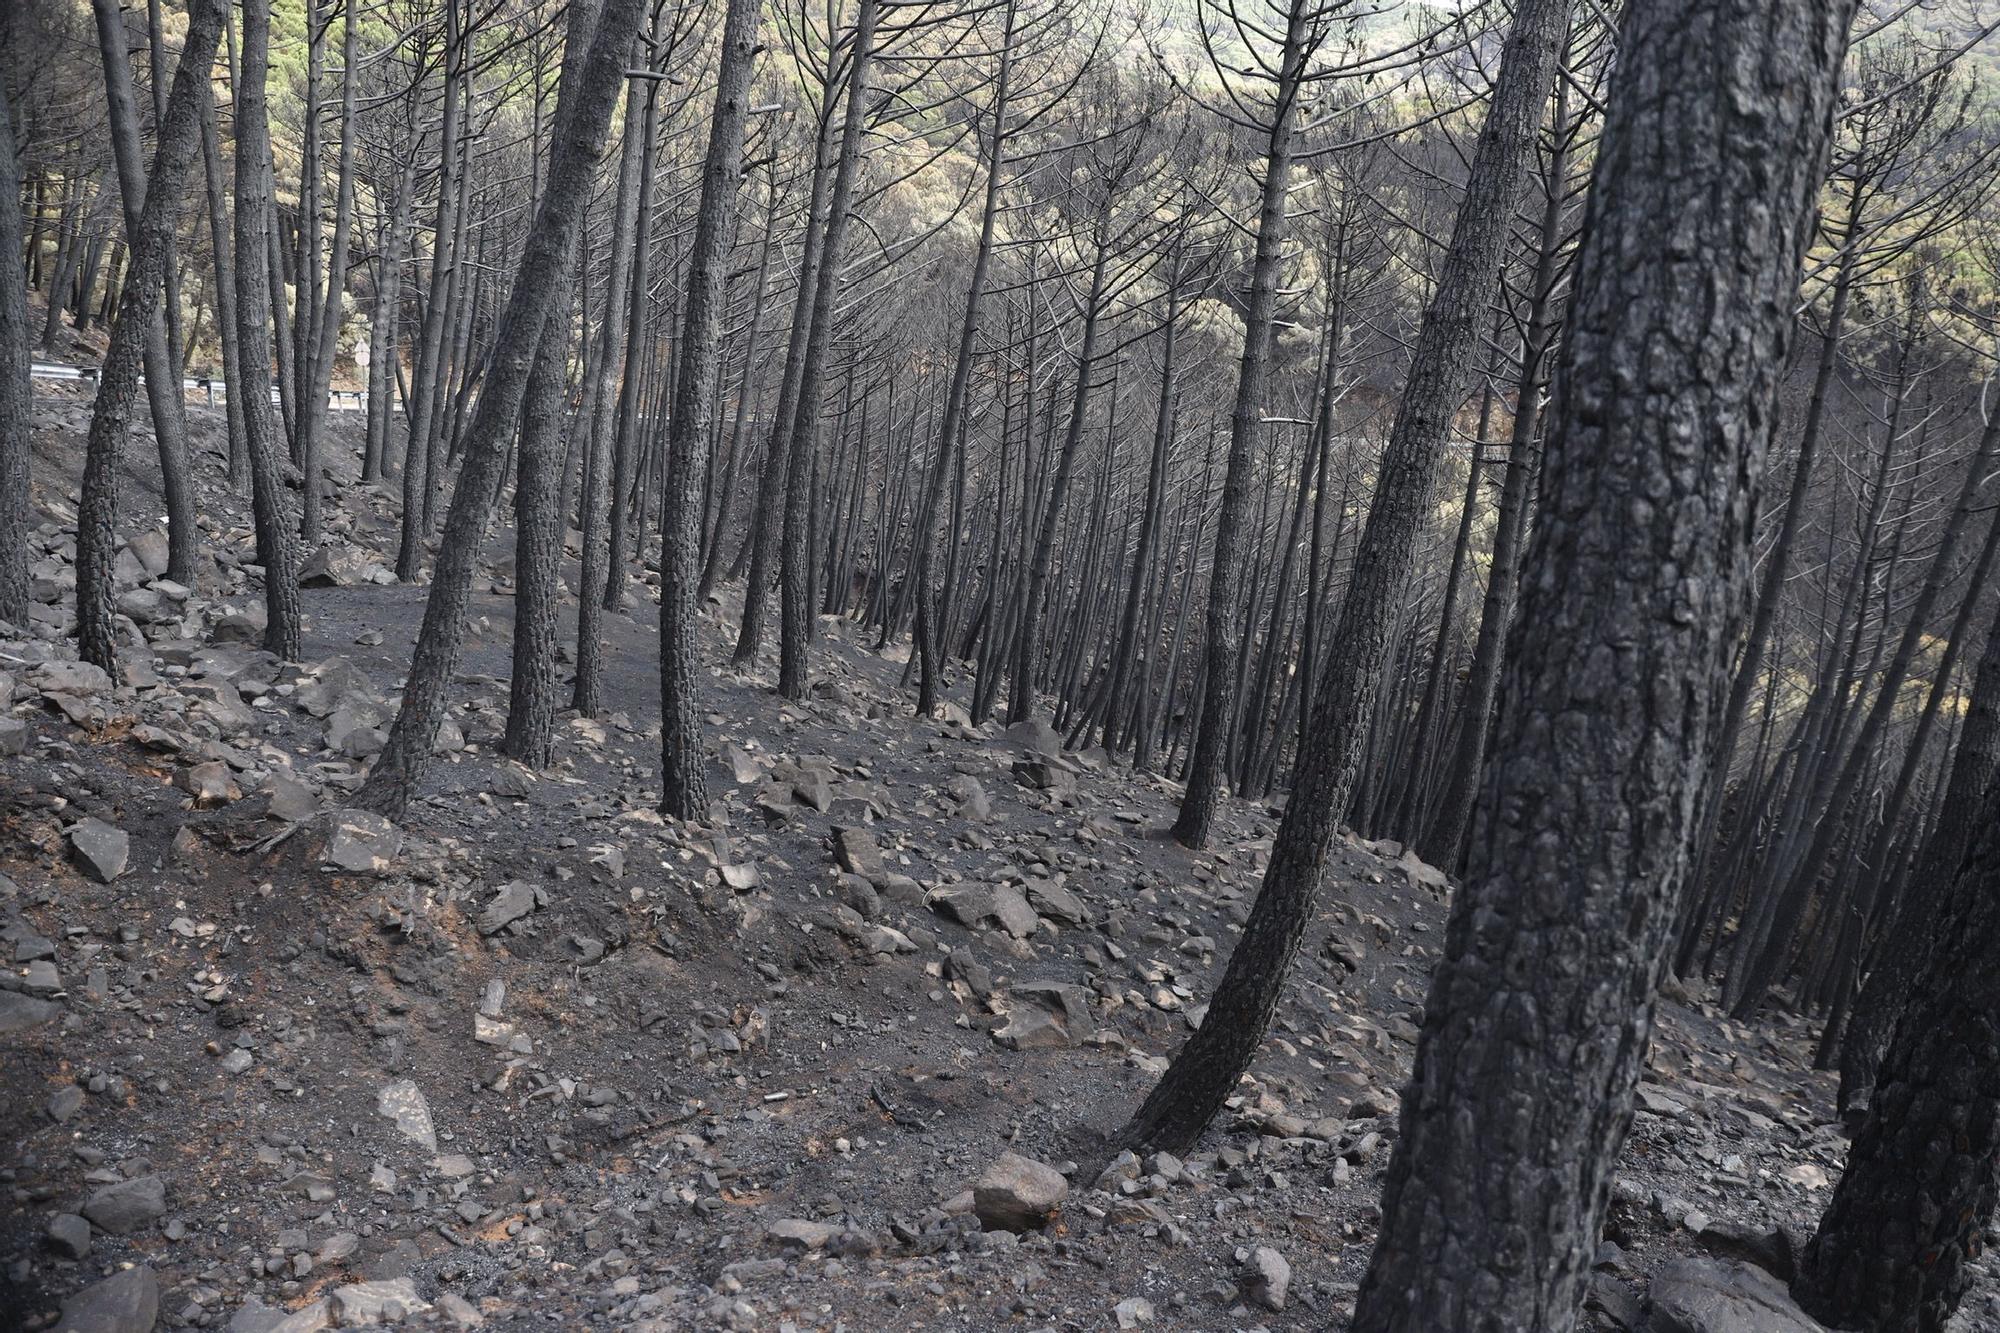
[90,0,200,584]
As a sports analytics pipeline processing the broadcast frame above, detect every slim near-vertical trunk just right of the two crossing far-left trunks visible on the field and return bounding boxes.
[234,0,300,660]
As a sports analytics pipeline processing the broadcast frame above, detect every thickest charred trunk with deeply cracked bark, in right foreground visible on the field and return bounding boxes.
[1352,0,1854,1333]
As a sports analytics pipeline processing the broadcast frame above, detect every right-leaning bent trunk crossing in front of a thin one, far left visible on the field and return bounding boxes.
[74,0,228,671]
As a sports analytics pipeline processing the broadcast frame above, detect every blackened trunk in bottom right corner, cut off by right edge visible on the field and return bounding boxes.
[1794,764,2000,1333]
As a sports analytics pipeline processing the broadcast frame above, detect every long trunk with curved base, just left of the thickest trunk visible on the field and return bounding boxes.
[1120,0,1568,1149]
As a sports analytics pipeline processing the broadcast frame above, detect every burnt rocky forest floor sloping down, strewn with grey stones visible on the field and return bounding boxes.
[0,384,2000,1331]
